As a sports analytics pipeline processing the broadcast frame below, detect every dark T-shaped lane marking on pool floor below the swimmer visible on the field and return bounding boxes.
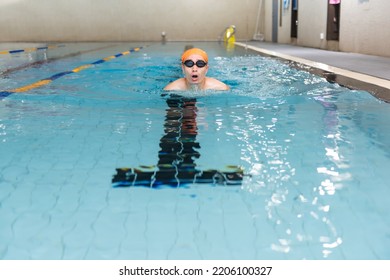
[112,95,244,188]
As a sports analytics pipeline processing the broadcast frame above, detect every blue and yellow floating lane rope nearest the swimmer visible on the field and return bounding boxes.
[0,47,144,99]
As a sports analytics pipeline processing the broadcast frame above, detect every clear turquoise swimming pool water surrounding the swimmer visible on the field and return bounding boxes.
[0,43,390,260]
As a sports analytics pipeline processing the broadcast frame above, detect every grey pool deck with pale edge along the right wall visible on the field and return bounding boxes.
[236,41,390,102]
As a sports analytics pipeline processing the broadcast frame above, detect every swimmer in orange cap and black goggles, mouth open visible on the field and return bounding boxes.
[164,48,229,90]
